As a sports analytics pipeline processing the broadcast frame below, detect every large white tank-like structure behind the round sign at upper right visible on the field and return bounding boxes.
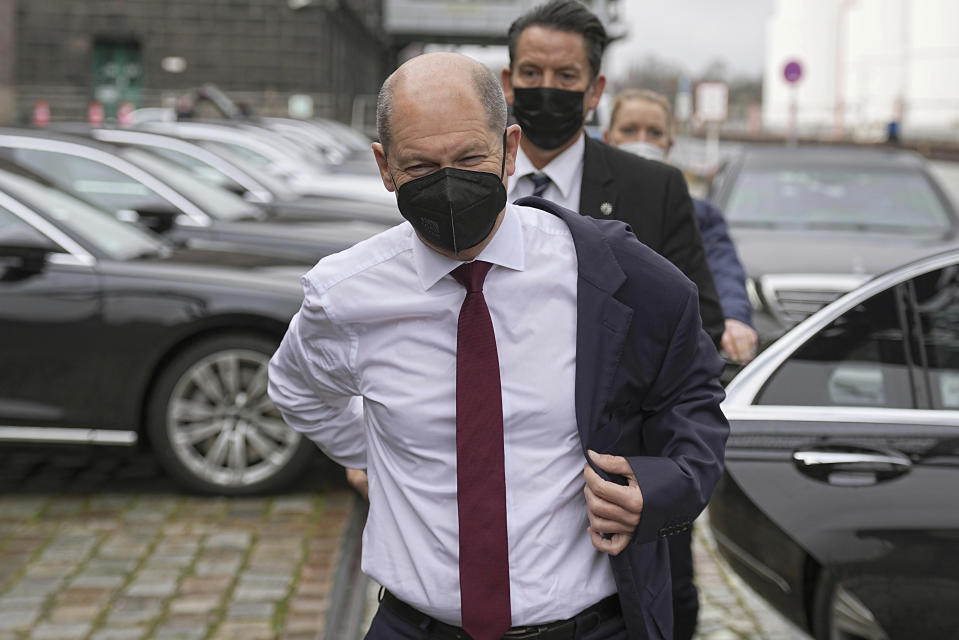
[762,0,959,140]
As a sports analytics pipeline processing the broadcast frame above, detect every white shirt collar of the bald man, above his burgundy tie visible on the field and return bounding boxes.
[413,204,526,290]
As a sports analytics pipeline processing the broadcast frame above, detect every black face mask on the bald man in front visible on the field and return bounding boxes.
[394,132,506,253]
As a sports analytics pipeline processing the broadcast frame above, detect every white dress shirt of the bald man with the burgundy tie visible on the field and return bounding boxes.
[270,204,616,625]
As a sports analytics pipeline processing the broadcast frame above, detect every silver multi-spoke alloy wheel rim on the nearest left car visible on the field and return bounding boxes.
[167,349,300,487]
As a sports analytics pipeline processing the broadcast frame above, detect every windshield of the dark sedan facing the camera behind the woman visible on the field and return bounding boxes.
[725,167,953,234]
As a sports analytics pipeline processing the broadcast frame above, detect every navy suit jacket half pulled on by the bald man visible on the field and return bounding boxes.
[516,197,729,640]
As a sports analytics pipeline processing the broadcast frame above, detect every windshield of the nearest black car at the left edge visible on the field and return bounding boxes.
[0,170,166,260]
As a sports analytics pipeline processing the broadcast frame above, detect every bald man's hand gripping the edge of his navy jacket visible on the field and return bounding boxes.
[584,451,643,556]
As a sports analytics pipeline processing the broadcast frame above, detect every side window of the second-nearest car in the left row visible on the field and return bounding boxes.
[8,149,162,211]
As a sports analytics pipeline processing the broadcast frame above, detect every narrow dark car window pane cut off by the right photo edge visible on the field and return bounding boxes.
[912,265,959,411]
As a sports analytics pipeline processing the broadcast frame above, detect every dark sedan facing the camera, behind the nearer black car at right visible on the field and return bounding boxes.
[710,145,959,346]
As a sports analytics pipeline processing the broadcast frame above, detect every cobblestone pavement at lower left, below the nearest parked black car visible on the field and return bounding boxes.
[0,445,354,640]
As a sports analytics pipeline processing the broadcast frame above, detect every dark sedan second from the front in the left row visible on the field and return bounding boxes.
[0,129,398,262]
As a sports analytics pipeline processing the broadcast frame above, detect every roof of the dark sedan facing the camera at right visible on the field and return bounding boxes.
[741,144,925,169]
